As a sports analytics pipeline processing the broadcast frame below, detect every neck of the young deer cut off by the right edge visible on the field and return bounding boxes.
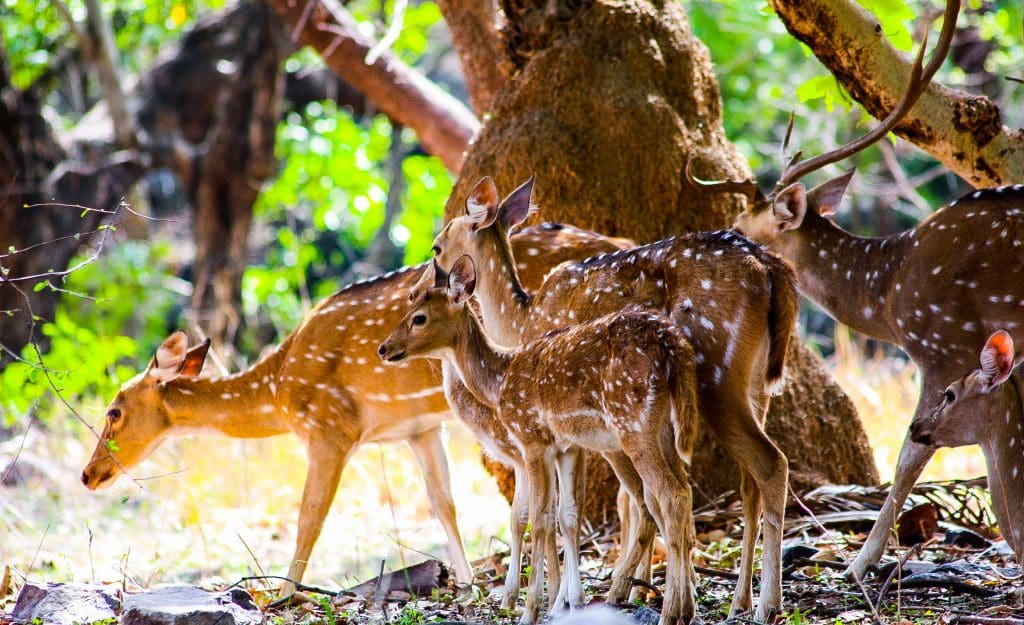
[981,372,1024,556]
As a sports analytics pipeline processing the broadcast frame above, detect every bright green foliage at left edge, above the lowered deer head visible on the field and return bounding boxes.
[0,241,182,423]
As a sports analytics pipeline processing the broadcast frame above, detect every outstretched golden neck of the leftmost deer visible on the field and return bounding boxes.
[165,345,291,439]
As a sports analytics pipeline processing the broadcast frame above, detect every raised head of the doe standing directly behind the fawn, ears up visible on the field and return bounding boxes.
[433,176,534,267]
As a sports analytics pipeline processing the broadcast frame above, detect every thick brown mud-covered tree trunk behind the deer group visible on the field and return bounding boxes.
[445,0,878,520]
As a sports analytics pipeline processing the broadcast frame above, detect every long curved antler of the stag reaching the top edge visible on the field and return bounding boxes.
[772,0,961,195]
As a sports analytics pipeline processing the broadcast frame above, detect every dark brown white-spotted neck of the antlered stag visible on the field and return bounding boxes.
[780,211,912,343]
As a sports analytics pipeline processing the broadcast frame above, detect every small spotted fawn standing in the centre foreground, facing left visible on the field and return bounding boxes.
[379,256,697,624]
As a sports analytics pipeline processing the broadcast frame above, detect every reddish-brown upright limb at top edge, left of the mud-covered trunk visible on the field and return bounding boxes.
[437,0,512,118]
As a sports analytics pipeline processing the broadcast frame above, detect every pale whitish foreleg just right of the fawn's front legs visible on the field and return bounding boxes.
[551,448,587,612]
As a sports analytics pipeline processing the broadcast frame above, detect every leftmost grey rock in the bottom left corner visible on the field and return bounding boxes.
[10,582,121,625]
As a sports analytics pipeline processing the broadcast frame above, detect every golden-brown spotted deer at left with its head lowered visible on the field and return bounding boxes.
[82,224,629,595]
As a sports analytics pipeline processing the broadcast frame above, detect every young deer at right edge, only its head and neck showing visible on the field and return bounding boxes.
[910,331,1024,563]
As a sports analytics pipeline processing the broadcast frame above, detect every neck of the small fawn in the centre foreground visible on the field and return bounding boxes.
[445,306,512,410]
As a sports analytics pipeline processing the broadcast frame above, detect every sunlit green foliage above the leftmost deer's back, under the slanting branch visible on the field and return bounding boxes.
[243,102,452,333]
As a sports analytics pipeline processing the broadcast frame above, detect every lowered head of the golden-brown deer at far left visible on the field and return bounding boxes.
[82,331,210,491]
